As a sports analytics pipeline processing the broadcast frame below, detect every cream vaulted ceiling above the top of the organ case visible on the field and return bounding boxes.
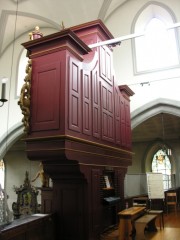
[0,0,129,56]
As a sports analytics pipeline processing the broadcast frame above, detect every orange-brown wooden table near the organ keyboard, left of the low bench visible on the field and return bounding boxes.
[118,207,146,240]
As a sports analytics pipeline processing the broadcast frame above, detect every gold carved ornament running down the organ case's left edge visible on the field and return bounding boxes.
[18,59,32,133]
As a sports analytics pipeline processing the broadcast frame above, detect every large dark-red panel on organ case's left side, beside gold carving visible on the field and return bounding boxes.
[31,56,61,131]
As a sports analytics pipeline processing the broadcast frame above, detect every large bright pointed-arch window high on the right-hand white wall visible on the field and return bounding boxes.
[134,5,179,73]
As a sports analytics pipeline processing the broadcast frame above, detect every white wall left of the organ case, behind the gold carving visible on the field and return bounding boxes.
[0,28,57,158]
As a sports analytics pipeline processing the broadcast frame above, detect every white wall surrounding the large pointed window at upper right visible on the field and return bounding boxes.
[105,0,180,112]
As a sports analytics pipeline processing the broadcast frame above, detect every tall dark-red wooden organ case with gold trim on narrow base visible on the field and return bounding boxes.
[22,20,133,240]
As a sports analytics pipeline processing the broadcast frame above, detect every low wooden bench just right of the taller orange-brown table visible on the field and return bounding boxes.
[135,214,157,240]
